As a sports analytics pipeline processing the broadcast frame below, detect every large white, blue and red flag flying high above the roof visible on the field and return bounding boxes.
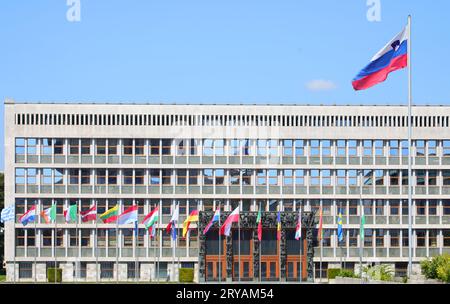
[352,27,408,90]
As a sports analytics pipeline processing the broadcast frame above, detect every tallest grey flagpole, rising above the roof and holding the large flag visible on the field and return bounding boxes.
[407,15,413,277]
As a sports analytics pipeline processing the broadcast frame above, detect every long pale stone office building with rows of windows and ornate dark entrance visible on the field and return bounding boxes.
[4,100,450,282]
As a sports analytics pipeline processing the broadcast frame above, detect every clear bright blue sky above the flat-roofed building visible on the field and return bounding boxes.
[0,0,450,170]
